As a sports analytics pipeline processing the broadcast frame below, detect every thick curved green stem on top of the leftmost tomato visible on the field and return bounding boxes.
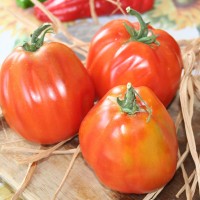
[22,23,53,52]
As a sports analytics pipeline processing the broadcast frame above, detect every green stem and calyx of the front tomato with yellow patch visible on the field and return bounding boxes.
[117,83,152,122]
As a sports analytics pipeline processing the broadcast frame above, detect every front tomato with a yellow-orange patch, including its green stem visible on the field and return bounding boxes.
[79,83,178,194]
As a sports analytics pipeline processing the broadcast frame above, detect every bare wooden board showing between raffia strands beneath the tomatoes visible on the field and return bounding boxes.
[0,95,200,200]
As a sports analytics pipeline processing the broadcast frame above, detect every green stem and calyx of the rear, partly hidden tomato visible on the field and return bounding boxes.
[124,7,160,45]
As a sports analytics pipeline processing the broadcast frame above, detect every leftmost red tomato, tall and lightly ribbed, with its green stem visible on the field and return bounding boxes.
[0,25,95,144]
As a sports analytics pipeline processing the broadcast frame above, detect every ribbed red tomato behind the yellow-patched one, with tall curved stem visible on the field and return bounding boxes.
[86,8,182,107]
